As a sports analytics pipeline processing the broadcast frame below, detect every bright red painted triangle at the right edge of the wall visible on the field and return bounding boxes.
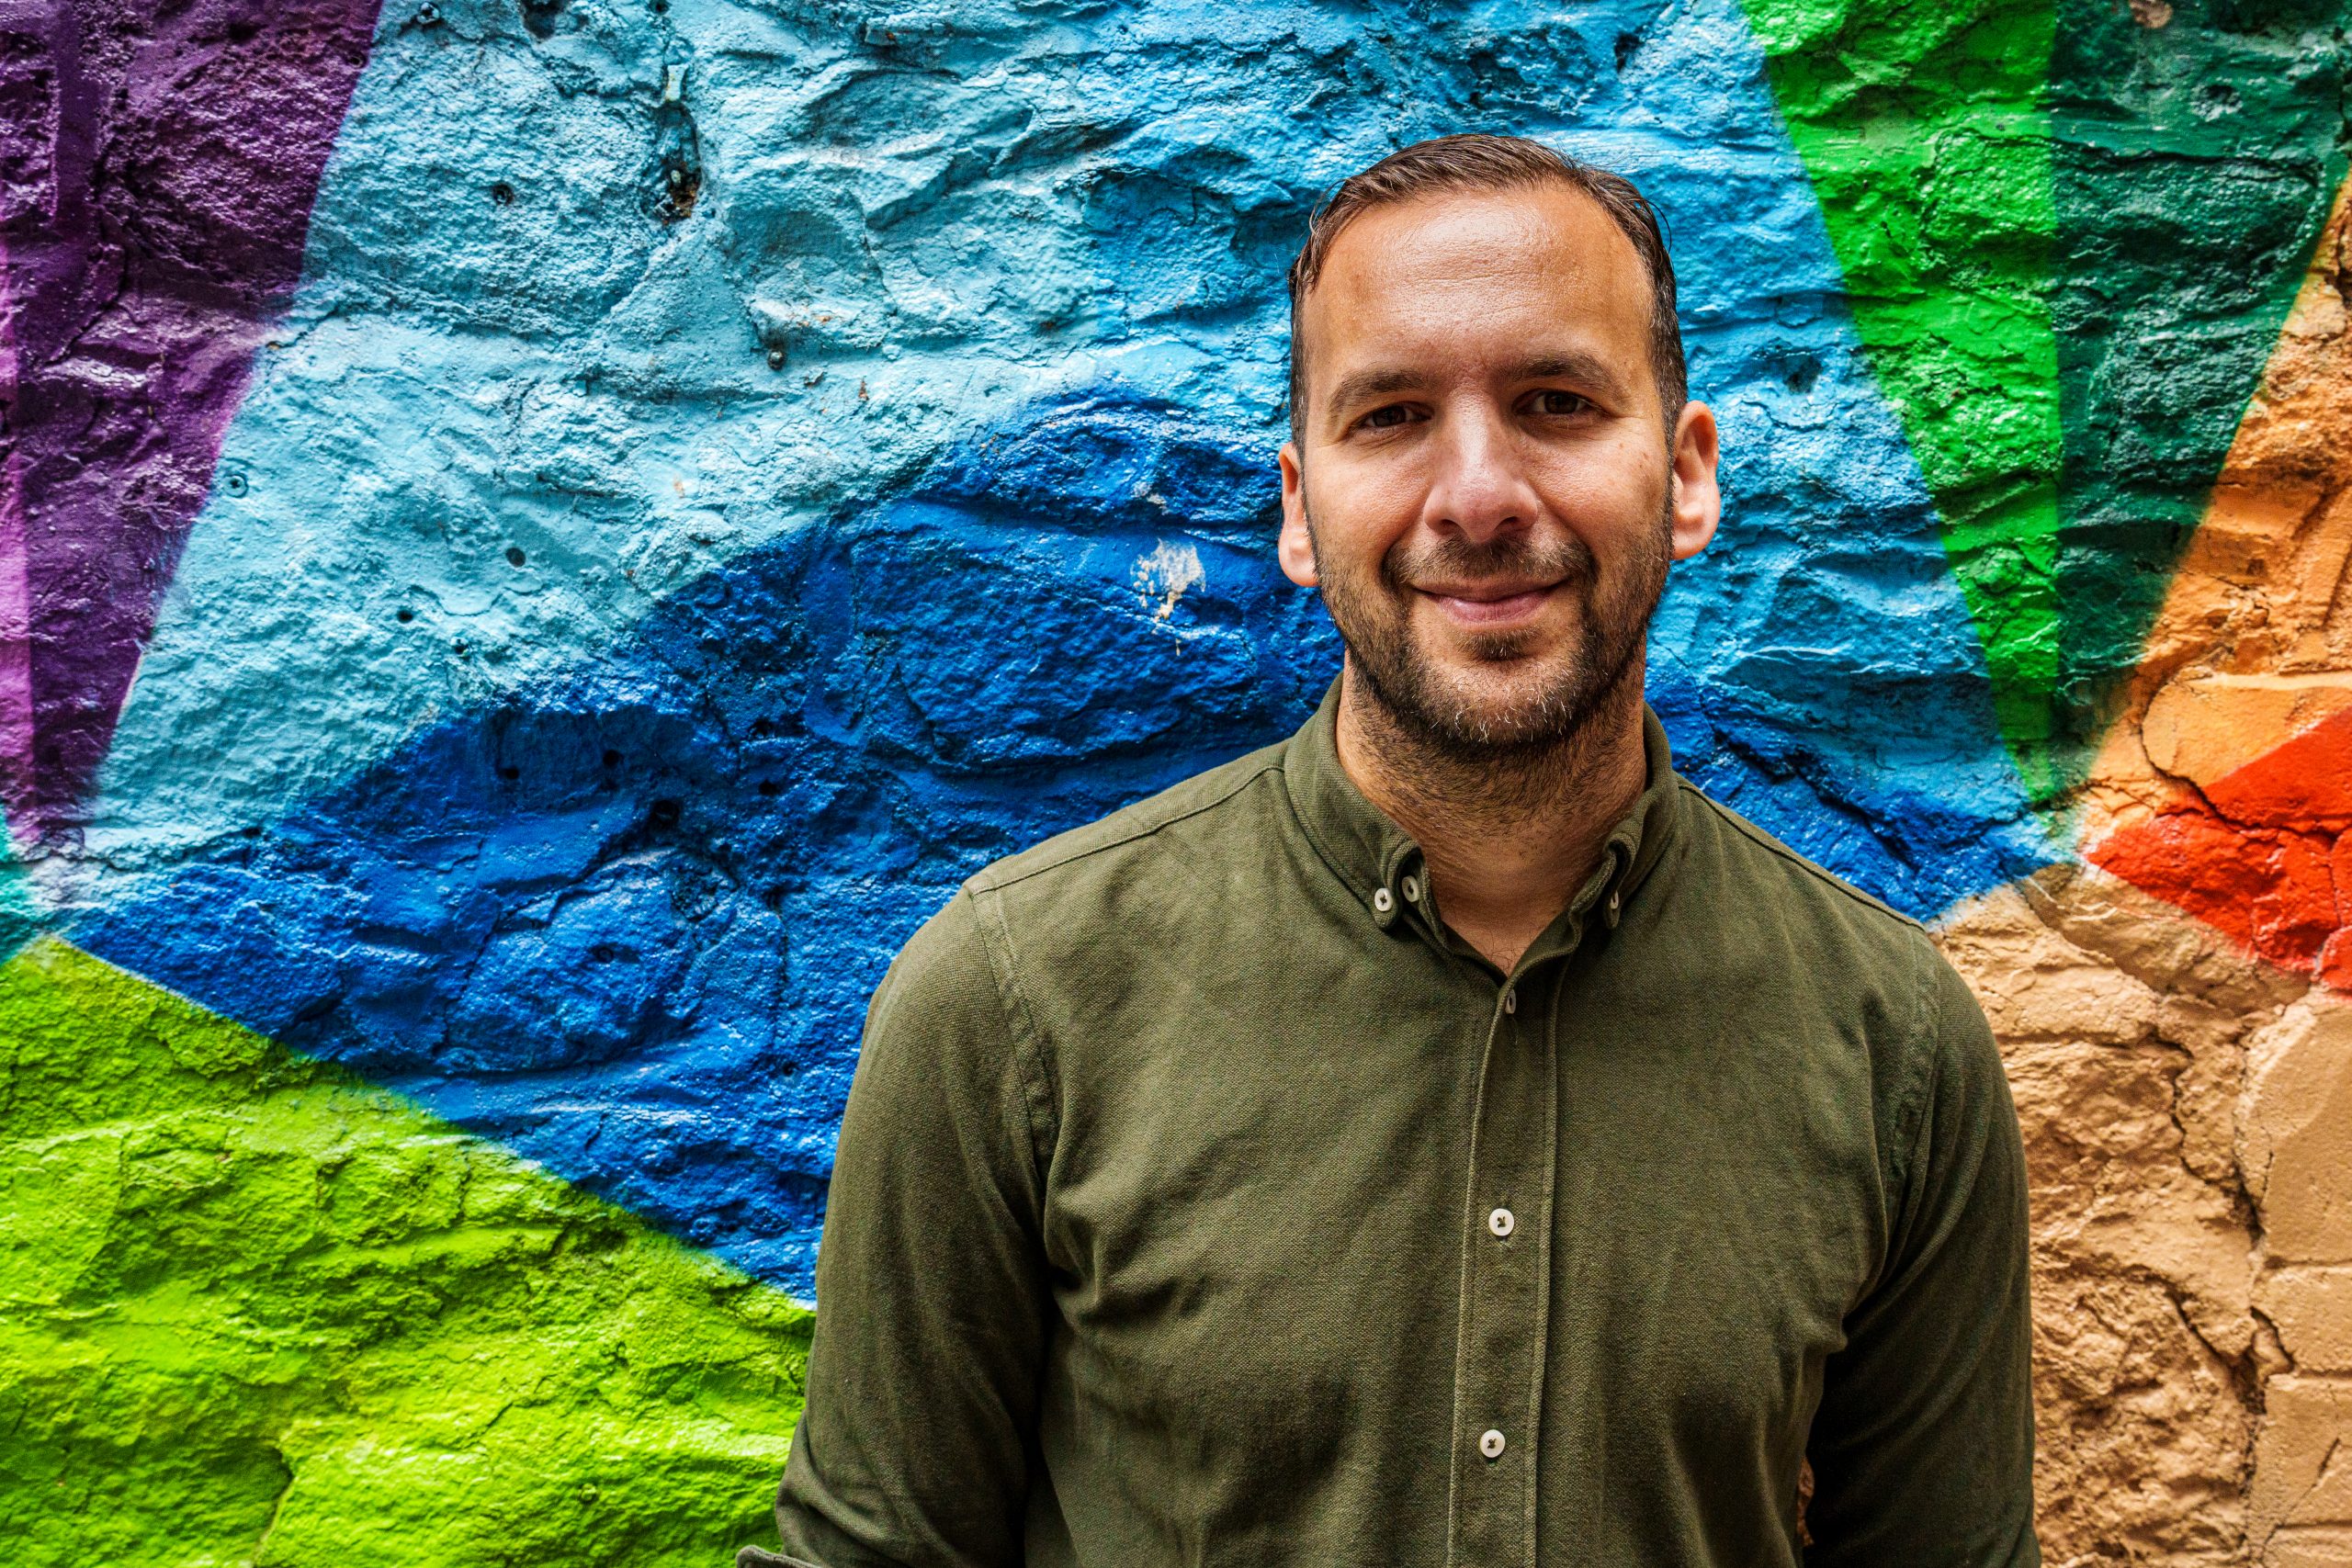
[2084,712,2352,989]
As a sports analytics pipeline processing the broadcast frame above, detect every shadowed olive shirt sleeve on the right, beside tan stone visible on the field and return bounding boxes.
[1804,957,2041,1568]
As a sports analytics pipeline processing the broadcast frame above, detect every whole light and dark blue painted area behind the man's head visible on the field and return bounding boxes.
[64,0,2046,1291]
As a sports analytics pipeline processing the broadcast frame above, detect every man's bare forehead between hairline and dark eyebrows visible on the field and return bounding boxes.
[1298,184,1651,381]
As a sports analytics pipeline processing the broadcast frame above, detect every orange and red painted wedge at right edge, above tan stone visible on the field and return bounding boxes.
[2084,181,2352,987]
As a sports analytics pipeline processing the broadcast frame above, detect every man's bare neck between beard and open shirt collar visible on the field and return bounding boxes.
[1339,659,1649,974]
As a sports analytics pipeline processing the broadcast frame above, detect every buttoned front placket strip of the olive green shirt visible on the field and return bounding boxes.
[1446,964,1559,1568]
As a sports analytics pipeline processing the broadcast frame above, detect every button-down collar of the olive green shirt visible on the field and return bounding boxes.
[1282,680,1681,957]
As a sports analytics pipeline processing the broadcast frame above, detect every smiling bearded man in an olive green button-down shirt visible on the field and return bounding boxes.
[743,136,2040,1568]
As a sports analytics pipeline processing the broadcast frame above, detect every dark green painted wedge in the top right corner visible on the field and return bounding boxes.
[2051,0,2352,761]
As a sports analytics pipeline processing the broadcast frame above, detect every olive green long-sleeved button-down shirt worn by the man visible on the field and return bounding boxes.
[743,696,2040,1568]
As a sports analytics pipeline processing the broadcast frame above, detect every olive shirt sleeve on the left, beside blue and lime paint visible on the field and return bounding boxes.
[741,888,1051,1568]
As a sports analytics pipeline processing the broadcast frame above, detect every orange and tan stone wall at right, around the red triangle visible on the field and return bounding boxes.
[1943,162,2352,1568]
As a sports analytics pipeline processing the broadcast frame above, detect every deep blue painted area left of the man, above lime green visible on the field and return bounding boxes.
[73,398,1339,1293]
